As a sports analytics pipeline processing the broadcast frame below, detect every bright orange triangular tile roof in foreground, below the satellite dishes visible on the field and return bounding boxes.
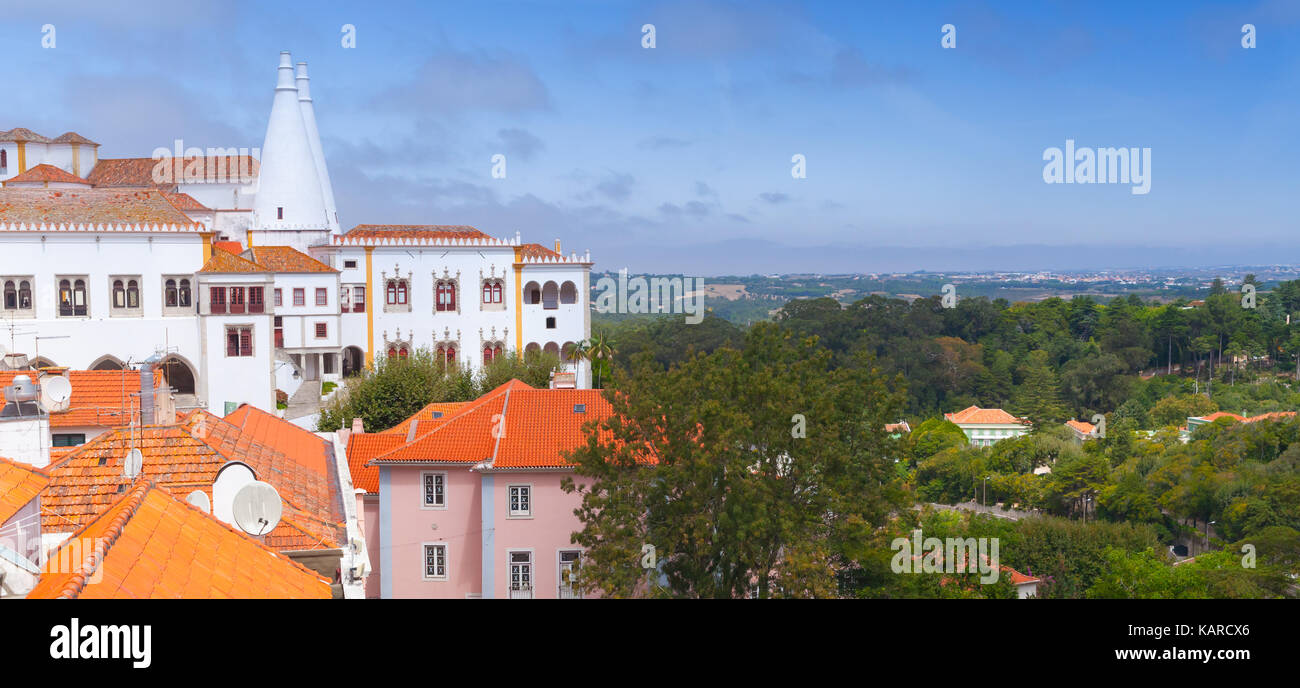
[27,480,333,600]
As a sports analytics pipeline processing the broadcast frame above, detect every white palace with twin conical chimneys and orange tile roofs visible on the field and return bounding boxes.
[0,52,592,415]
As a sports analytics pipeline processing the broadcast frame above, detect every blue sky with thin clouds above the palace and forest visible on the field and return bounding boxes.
[0,0,1300,276]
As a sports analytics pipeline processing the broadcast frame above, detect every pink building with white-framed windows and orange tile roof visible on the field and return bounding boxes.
[348,380,611,598]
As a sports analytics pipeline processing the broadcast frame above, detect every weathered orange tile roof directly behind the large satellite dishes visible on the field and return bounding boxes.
[42,410,345,550]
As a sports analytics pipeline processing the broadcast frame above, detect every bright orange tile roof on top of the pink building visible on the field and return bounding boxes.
[368,380,612,468]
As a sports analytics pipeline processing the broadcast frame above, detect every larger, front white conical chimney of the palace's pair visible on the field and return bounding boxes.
[254,51,329,232]
